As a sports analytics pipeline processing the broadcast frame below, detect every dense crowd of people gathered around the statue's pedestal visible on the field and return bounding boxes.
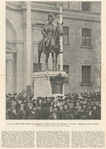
[6,92,101,120]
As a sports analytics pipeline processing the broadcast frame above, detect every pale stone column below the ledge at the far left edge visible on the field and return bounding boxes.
[6,53,13,93]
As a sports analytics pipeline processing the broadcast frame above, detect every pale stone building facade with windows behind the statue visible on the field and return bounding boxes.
[6,1,101,94]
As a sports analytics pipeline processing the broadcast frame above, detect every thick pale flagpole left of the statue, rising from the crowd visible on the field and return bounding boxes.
[26,1,32,101]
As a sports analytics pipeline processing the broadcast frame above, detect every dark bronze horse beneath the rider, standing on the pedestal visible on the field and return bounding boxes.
[38,22,63,70]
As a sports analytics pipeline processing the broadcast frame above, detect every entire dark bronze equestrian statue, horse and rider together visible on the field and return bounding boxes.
[38,13,63,70]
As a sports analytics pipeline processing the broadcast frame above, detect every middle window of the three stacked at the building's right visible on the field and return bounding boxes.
[82,28,91,46]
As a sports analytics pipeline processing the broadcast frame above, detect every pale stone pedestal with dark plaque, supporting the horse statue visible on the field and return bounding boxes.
[33,71,67,98]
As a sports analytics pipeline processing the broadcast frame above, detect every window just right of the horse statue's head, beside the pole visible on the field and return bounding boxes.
[63,26,69,45]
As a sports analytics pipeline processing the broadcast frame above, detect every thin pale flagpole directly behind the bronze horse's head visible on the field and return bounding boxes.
[60,2,63,71]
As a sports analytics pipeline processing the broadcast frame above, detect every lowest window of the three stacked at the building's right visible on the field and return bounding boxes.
[82,66,91,85]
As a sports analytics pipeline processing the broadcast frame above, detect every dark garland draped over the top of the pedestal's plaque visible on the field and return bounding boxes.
[50,73,65,85]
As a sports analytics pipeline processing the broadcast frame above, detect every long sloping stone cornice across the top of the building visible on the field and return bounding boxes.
[6,2,101,24]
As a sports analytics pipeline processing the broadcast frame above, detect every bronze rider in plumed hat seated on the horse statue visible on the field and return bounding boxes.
[41,13,55,52]
